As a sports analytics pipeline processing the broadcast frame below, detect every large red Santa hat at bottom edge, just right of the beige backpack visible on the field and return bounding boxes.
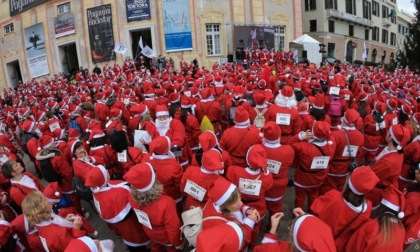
[197,221,244,252]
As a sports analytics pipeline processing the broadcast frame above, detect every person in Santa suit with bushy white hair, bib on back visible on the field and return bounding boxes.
[267,86,301,144]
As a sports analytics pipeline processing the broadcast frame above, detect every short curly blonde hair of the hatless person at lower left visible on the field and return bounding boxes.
[22,191,51,226]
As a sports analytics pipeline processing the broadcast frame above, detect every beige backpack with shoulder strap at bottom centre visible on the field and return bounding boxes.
[180,207,228,247]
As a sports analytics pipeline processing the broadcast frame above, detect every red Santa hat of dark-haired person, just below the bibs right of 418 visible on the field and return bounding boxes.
[348,166,379,195]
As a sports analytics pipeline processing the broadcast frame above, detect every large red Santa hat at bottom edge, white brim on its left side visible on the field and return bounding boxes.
[292,214,335,251]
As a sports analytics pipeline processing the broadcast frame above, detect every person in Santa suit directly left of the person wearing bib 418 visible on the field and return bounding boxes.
[261,121,295,216]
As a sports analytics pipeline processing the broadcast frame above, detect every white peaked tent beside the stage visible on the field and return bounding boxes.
[290,34,322,65]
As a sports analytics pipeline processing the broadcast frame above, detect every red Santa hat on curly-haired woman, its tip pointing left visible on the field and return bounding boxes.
[123,162,156,192]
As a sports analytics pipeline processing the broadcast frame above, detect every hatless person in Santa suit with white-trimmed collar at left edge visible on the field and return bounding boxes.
[1,160,44,206]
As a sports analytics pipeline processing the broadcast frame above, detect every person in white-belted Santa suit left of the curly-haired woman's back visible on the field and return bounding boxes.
[85,163,149,252]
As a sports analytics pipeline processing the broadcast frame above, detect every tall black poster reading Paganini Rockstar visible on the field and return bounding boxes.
[87,4,115,63]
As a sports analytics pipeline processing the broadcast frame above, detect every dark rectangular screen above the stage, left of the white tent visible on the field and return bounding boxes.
[234,25,275,50]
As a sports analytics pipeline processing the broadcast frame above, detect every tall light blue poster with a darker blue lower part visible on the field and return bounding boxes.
[162,0,192,52]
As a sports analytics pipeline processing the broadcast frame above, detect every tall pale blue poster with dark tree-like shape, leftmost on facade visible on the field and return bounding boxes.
[25,23,50,78]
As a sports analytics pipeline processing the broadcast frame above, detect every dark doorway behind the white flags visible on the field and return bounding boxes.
[130,28,153,69]
